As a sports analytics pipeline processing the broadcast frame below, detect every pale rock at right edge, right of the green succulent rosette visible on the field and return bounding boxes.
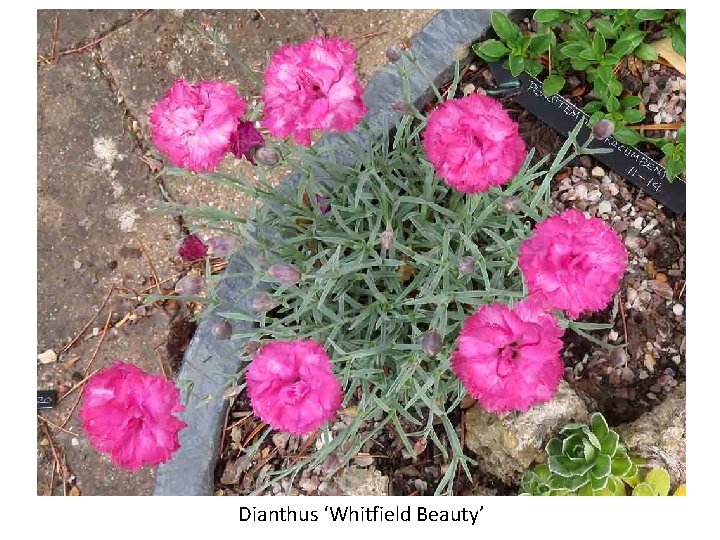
[616,383,685,485]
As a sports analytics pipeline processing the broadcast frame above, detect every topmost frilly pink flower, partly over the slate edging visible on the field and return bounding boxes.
[262,37,367,146]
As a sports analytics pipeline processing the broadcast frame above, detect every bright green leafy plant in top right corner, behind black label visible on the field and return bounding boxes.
[473,9,685,180]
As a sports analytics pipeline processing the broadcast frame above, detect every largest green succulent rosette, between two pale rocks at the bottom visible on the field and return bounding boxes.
[545,413,637,495]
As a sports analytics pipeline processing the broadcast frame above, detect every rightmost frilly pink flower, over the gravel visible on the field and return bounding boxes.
[518,210,627,318]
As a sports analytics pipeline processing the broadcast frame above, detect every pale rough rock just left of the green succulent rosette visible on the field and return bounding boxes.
[465,381,588,483]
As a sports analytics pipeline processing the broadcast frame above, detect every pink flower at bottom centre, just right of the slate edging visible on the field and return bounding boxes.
[245,339,342,434]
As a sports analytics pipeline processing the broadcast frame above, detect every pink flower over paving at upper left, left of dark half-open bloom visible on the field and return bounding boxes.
[150,79,247,172]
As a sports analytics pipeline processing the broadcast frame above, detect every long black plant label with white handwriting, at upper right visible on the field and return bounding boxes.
[490,62,685,215]
